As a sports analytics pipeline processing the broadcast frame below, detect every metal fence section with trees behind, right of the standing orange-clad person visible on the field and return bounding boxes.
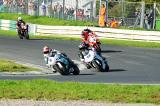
[101,0,160,29]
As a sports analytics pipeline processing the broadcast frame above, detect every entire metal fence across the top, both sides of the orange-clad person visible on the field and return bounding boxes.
[0,0,160,29]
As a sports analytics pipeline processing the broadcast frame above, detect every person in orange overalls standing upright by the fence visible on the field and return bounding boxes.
[99,4,106,27]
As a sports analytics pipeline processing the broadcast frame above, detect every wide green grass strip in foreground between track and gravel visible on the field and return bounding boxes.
[0,79,160,104]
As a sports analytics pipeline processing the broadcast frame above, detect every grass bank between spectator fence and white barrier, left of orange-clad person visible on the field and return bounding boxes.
[0,13,96,26]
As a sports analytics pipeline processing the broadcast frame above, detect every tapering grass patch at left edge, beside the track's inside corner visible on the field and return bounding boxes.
[0,59,38,72]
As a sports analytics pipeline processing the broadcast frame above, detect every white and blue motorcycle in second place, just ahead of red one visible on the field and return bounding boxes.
[82,48,109,72]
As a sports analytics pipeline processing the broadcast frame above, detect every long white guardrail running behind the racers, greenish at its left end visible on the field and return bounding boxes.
[0,20,160,41]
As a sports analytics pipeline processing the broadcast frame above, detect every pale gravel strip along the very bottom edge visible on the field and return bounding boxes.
[0,99,157,106]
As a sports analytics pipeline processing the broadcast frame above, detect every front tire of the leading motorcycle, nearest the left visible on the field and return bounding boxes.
[56,62,70,75]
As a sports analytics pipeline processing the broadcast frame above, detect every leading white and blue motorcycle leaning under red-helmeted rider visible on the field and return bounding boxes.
[44,54,80,75]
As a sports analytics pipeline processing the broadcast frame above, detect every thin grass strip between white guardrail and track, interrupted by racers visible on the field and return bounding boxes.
[0,30,160,48]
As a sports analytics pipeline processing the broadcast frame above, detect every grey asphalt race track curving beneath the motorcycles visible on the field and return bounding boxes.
[0,37,160,84]
